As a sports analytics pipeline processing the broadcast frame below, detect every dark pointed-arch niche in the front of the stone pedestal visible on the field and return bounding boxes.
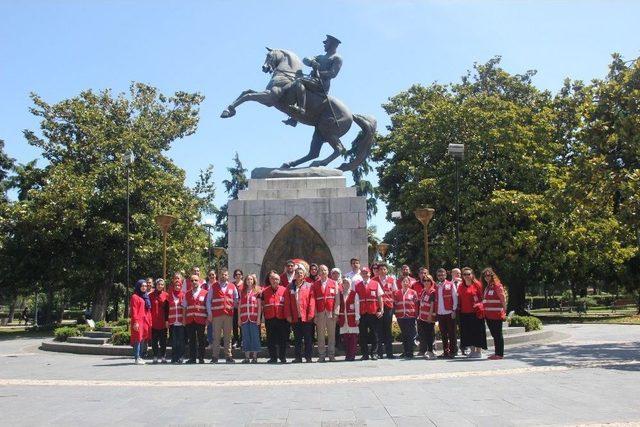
[260,215,334,280]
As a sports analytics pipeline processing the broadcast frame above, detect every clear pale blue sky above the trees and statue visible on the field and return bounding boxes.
[0,0,640,236]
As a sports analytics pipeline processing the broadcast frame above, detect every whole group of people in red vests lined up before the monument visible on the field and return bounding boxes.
[130,258,506,364]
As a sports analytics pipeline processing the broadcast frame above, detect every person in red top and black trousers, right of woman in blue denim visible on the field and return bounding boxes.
[262,270,289,363]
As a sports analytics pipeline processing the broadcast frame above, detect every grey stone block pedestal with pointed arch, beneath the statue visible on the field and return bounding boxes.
[228,176,367,282]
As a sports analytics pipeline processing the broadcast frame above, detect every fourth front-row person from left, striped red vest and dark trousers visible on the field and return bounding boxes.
[183,274,207,363]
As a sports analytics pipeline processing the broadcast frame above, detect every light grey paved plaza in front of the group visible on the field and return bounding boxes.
[0,325,640,426]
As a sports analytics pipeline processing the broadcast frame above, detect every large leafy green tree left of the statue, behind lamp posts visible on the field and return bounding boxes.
[17,83,210,320]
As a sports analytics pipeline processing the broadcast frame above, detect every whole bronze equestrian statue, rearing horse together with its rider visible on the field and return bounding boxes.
[220,35,376,171]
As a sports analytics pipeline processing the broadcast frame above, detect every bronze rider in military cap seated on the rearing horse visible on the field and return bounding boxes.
[282,34,342,126]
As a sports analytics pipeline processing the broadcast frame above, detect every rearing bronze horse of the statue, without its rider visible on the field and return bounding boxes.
[220,48,376,171]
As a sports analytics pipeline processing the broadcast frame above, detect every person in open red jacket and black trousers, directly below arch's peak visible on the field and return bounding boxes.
[284,265,316,363]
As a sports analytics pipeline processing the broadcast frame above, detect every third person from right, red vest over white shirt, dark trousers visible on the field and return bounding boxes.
[436,268,458,359]
